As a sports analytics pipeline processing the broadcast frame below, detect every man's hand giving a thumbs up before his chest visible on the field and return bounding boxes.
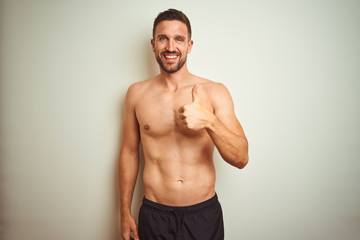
[178,84,214,131]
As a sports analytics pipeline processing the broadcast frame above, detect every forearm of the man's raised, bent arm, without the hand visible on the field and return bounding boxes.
[206,115,249,169]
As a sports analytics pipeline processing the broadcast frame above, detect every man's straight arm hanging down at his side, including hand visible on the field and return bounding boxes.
[119,86,140,240]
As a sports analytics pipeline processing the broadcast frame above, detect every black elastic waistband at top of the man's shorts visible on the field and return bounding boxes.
[143,193,218,212]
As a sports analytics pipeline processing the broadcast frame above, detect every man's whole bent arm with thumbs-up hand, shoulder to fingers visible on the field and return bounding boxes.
[179,83,249,169]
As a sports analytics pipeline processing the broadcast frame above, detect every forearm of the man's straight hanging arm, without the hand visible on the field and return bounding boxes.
[119,152,139,215]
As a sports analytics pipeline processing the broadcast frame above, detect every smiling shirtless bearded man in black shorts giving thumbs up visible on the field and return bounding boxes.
[119,9,248,240]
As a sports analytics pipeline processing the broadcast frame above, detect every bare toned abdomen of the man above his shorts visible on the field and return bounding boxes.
[143,135,216,206]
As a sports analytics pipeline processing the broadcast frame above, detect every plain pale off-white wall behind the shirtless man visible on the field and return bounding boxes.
[0,0,360,240]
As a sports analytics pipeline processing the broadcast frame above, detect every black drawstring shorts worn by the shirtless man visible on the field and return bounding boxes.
[138,194,224,240]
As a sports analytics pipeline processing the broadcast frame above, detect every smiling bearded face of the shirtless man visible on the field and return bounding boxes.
[151,20,193,73]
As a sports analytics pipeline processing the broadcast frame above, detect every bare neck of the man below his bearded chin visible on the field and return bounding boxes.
[159,63,192,91]
